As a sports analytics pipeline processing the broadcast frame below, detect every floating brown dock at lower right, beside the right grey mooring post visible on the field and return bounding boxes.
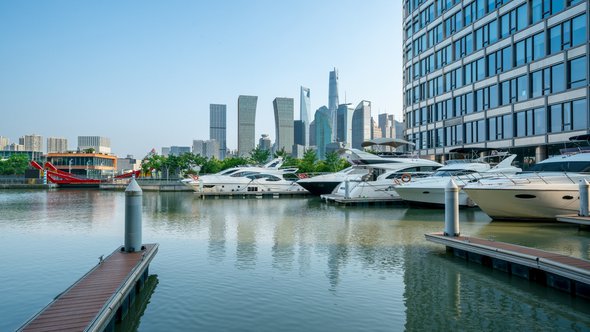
[425,233,590,299]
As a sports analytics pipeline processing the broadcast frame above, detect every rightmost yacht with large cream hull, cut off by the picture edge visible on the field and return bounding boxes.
[463,152,590,220]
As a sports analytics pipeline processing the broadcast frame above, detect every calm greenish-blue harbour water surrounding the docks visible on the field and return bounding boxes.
[0,191,590,331]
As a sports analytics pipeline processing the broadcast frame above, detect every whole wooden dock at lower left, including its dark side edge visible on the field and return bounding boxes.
[19,244,158,331]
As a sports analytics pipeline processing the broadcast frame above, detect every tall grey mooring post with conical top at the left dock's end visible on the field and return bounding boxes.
[125,177,143,252]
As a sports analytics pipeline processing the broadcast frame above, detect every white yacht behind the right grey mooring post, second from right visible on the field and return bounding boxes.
[395,152,522,207]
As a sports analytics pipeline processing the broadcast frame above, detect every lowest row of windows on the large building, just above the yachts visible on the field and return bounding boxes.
[408,99,588,149]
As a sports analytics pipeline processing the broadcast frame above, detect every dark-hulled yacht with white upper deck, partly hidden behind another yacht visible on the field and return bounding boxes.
[297,149,442,195]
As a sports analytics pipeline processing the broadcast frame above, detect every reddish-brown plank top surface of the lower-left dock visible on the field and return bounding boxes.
[20,244,158,331]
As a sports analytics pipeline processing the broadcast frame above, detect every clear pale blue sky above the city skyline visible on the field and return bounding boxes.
[0,0,402,158]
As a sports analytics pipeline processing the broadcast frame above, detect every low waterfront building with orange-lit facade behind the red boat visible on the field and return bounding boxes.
[47,152,117,178]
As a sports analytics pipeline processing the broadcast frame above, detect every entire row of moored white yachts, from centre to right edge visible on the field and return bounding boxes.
[182,142,590,220]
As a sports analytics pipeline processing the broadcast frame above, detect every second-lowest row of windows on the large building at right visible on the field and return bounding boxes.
[406,56,588,128]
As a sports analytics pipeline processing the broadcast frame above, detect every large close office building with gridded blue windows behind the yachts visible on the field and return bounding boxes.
[403,0,590,162]
